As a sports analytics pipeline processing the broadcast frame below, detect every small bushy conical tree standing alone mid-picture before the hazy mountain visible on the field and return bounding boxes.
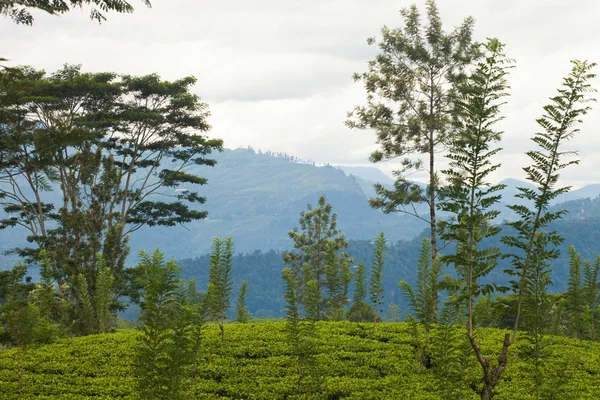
[283,195,352,320]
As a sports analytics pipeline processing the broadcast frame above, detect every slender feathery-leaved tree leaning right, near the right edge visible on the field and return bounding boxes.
[502,60,596,398]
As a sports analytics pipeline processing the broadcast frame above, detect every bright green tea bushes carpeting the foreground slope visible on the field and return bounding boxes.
[0,322,600,400]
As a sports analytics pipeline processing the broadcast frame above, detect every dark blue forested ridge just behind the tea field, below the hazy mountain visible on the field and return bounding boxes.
[176,219,600,317]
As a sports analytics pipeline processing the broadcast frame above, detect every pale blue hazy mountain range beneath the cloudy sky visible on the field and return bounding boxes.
[0,149,600,261]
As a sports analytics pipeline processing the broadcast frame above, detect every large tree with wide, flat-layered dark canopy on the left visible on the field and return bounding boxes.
[0,66,222,334]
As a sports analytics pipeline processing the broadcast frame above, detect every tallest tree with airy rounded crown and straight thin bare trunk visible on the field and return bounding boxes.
[346,0,477,318]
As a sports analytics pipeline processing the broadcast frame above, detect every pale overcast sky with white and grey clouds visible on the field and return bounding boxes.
[0,0,600,187]
